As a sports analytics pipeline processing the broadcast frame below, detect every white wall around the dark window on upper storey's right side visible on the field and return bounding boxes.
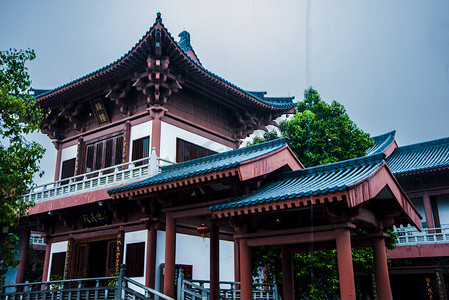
[160,122,232,162]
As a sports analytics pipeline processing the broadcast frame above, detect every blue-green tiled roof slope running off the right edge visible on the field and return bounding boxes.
[387,138,449,175]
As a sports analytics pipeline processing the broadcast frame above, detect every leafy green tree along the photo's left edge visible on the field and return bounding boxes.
[0,49,45,283]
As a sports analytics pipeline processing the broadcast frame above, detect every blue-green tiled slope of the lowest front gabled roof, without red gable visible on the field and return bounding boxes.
[210,153,385,211]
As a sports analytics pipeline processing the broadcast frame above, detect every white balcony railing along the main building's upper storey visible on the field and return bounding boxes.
[23,151,172,203]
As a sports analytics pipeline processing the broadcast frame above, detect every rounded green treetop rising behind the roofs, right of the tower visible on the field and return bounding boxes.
[279,88,373,167]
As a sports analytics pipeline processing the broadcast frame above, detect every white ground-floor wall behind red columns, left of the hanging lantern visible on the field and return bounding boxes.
[155,231,234,289]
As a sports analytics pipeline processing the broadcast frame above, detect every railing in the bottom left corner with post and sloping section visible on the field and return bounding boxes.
[0,265,173,300]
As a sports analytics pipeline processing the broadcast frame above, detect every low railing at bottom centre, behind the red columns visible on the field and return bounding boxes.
[177,269,279,300]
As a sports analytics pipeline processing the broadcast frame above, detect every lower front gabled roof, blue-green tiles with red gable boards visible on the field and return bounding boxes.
[210,153,420,226]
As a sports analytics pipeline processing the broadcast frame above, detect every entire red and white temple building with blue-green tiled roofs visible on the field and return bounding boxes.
[0,14,449,300]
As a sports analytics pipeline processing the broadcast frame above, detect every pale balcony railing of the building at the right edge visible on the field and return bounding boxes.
[395,224,449,246]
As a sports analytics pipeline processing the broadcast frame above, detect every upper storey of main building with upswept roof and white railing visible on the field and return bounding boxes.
[26,14,295,211]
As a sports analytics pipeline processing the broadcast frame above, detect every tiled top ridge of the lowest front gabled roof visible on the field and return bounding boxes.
[279,152,385,178]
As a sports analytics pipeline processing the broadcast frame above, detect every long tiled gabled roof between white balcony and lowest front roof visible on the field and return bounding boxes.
[108,138,302,196]
